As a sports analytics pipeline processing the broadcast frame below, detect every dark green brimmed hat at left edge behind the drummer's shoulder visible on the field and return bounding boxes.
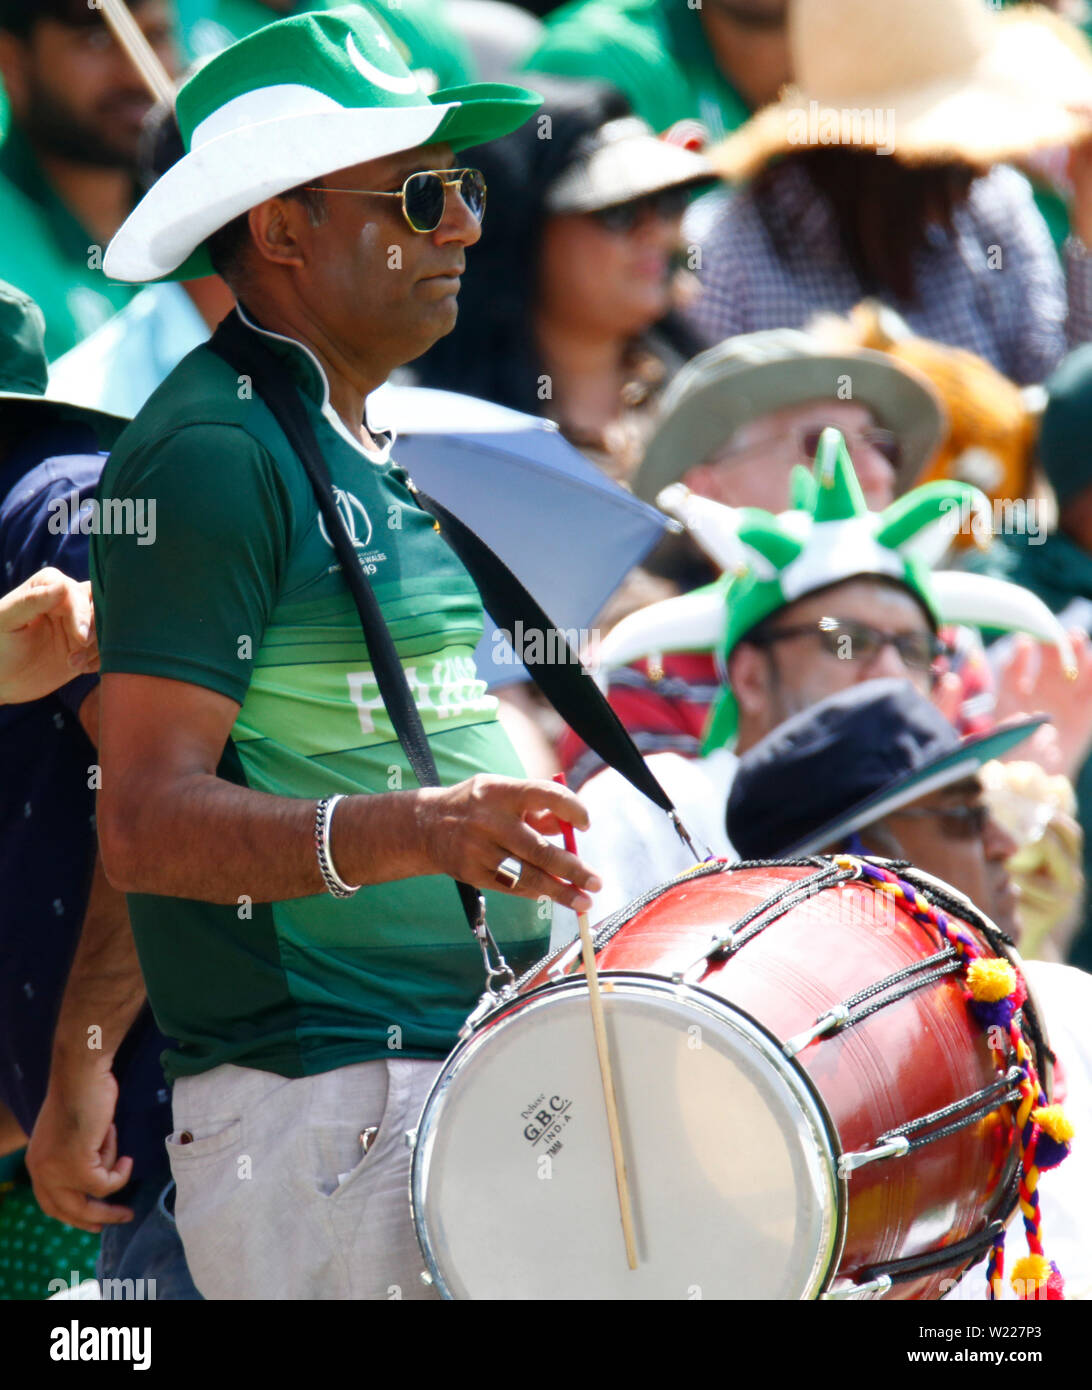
[0,281,128,449]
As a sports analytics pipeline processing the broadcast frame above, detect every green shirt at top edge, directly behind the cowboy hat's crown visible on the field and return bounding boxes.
[176,0,475,92]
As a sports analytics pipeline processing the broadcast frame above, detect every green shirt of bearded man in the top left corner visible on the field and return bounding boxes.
[0,125,136,360]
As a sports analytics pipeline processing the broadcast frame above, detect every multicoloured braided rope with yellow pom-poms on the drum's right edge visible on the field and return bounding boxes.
[834,855,1073,1300]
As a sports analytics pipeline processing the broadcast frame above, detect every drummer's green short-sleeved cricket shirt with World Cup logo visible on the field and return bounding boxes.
[92,309,550,1077]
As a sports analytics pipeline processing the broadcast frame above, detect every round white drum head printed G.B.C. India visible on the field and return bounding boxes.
[413,976,842,1300]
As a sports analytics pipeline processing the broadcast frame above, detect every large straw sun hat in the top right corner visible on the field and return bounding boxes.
[710,0,1092,179]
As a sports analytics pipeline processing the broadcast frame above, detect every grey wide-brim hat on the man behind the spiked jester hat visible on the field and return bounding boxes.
[632,328,948,502]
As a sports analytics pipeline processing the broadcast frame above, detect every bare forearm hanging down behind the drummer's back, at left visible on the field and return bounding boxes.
[53,856,144,1070]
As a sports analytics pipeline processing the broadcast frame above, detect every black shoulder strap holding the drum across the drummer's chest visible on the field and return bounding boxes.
[208,313,700,906]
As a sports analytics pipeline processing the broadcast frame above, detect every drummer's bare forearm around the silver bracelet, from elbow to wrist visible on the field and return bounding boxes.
[100,774,438,904]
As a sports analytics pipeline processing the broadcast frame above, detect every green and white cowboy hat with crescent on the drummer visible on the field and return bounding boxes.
[103,6,540,284]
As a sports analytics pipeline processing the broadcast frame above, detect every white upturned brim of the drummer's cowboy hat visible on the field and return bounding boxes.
[103,101,458,285]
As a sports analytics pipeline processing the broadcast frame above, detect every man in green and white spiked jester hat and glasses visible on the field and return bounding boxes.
[556,430,1073,935]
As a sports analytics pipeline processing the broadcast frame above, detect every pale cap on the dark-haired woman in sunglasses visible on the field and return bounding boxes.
[545,115,717,213]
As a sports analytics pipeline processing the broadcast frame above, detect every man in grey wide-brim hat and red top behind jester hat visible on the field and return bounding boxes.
[559,328,946,781]
